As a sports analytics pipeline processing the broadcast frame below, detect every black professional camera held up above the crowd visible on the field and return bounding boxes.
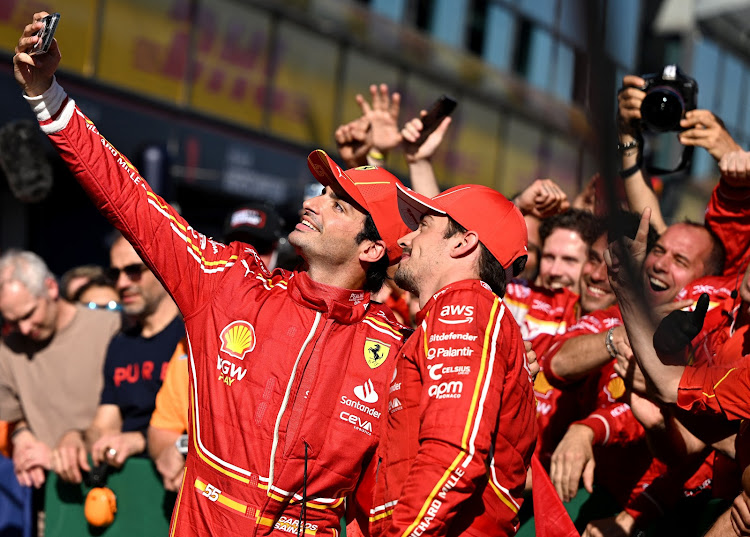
[641,65,698,132]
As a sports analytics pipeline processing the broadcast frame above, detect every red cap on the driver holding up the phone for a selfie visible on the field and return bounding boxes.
[307,149,409,265]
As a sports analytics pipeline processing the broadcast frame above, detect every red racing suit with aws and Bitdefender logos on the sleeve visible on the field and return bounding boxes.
[368,280,536,537]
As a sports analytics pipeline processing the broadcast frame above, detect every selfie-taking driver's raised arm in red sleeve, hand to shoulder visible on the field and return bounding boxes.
[13,12,238,317]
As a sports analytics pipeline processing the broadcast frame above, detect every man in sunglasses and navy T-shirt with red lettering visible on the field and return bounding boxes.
[52,235,185,483]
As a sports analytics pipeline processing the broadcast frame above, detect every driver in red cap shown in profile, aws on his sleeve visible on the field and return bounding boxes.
[369,185,536,536]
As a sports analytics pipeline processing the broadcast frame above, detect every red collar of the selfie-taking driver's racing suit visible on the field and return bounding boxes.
[288,272,370,324]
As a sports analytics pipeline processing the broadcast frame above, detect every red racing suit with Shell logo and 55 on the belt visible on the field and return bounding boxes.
[30,83,403,537]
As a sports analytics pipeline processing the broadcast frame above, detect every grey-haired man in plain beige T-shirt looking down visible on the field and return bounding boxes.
[0,250,120,488]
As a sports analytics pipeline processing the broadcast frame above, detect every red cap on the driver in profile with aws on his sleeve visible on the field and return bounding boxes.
[398,185,528,270]
